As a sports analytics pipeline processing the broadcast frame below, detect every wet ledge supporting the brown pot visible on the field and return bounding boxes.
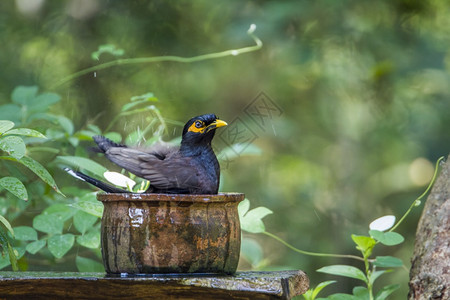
[0,270,309,300]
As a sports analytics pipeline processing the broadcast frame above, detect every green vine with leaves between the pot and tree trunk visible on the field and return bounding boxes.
[239,157,443,300]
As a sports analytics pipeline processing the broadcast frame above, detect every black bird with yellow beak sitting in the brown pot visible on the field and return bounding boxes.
[66,114,227,194]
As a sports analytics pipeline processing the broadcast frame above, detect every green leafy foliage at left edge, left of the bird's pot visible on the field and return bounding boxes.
[0,86,106,270]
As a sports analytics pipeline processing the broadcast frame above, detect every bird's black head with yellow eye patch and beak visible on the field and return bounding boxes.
[181,114,228,145]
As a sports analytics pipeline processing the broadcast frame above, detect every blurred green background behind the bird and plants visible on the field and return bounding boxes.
[0,0,450,299]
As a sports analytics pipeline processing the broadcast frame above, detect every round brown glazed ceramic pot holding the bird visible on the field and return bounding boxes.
[97,193,244,274]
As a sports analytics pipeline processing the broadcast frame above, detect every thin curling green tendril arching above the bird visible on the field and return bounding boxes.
[50,24,263,89]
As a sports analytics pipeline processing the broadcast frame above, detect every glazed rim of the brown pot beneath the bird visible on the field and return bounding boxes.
[97,193,245,203]
